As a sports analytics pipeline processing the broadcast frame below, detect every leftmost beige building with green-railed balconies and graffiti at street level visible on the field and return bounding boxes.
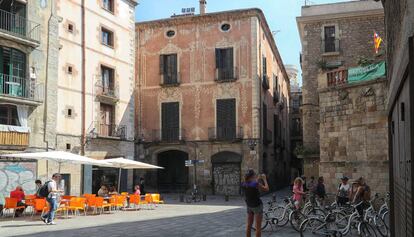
[0,0,59,203]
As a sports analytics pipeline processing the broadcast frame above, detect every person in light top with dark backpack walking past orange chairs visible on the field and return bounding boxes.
[39,173,62,225]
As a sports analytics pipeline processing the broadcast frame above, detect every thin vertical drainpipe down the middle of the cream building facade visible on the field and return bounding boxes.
[80,0,86,192]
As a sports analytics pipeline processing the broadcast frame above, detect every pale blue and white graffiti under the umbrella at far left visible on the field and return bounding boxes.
[0,162,36,203]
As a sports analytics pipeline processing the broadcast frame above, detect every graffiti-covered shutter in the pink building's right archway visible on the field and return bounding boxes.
[213,163,240,195]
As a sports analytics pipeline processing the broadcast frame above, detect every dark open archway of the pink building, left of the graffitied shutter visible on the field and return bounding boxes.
[157,150,188,193]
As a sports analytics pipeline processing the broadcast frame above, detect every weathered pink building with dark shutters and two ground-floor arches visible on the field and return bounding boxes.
[136,8,290,194]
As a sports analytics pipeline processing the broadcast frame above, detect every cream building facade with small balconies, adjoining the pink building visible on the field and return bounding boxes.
[56,0,137,195]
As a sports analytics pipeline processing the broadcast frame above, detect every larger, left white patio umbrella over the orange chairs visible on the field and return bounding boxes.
[0,151,112,173]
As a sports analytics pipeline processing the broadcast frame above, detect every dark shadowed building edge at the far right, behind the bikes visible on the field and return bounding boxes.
[382,0,414,237]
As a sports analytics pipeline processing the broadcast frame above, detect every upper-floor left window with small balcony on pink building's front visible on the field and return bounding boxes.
[160,54,178,85]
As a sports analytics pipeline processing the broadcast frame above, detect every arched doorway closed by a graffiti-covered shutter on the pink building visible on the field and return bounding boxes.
[211,151,242,195]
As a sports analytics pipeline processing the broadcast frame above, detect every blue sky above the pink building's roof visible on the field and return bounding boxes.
[135,0,347,85]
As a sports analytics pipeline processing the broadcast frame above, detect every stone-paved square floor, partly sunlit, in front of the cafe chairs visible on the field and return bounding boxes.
[0,189,308,237]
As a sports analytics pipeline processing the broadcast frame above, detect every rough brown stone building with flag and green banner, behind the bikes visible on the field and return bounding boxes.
[297,1,388,192]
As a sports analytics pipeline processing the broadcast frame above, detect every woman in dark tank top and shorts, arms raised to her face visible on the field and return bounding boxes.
[242,169,269,237]
